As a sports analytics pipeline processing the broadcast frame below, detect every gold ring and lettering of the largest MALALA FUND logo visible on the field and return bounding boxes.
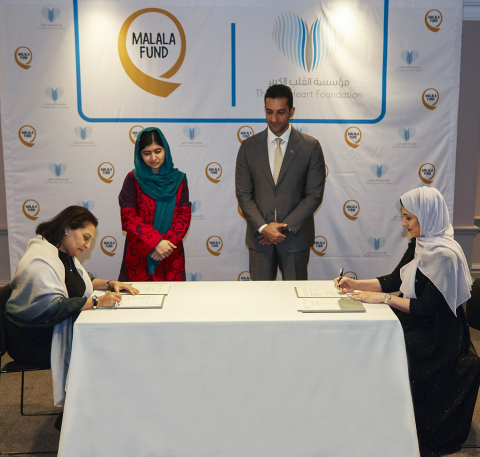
[118,8,187,97]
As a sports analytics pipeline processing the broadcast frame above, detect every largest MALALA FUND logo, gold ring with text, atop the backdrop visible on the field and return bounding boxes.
[118,8,187,97]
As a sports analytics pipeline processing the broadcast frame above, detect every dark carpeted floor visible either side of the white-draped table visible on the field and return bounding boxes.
[0,329,480,457]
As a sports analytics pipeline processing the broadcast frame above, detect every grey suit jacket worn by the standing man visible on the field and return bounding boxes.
[235,127,325,252]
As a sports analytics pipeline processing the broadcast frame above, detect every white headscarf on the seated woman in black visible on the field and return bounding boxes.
[400,186,473,315]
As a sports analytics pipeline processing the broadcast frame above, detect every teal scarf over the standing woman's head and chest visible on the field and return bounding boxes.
[133,127,185,274]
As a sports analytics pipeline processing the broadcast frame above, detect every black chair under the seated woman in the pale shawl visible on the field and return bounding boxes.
[0,284,59,455]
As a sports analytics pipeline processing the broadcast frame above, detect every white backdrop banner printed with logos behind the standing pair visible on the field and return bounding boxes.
[0,0,463,280]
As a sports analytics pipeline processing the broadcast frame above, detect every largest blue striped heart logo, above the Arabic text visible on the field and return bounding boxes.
[272,13,344,72]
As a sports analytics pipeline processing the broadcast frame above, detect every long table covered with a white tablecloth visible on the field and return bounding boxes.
[58,281,419,457]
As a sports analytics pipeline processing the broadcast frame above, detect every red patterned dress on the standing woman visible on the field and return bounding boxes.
[118,172,192,281]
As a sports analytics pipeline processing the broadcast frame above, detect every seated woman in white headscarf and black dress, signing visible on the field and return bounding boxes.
[334,187,480,457]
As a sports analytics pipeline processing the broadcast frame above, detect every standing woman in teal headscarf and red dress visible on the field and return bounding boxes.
[118,127,192,281]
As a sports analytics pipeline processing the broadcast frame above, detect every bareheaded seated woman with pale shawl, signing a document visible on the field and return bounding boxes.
[5,206,138,406]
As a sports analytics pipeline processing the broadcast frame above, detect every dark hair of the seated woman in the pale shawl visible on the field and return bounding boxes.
[35,205,98,248]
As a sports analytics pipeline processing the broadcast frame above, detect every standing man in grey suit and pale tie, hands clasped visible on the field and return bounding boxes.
[235,84,325,281]
